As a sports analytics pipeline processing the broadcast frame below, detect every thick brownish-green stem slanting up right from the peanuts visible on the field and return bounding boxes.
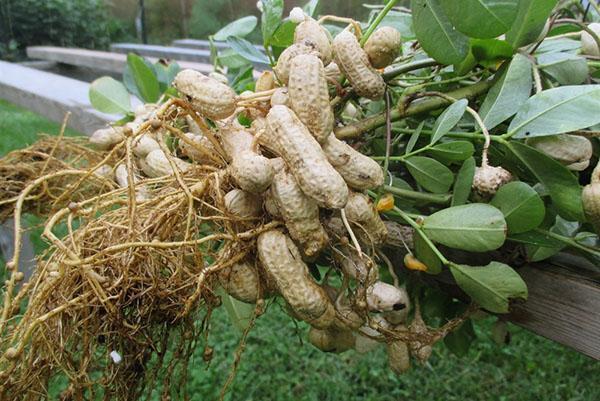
[335,80,493,139]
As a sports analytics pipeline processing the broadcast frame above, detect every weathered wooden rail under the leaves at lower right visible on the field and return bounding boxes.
[428,255,600,360]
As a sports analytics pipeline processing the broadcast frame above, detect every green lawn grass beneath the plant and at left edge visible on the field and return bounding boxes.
[0,97,600,401]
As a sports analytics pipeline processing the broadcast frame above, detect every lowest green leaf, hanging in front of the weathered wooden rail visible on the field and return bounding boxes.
[450,262,528,313]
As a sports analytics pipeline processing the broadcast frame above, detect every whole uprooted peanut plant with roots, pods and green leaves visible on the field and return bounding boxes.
[12,1,600,401]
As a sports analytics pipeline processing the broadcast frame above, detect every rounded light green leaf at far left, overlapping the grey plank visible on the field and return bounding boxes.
[88,77,131,114]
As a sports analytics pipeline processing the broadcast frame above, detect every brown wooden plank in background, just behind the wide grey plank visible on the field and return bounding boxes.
[27,46,213,74]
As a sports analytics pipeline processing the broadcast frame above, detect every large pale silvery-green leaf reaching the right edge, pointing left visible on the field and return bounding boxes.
[508,85,600,138]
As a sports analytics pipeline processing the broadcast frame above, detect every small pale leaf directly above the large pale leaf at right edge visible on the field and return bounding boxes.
[538,53,590,85]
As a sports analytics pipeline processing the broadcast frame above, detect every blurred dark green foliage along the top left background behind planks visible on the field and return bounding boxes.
[0,0,408,61]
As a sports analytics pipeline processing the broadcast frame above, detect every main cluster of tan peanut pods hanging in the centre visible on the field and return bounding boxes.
[86,17,431,372]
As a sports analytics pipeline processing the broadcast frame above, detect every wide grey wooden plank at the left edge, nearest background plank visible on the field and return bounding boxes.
[0,61,130,134]
